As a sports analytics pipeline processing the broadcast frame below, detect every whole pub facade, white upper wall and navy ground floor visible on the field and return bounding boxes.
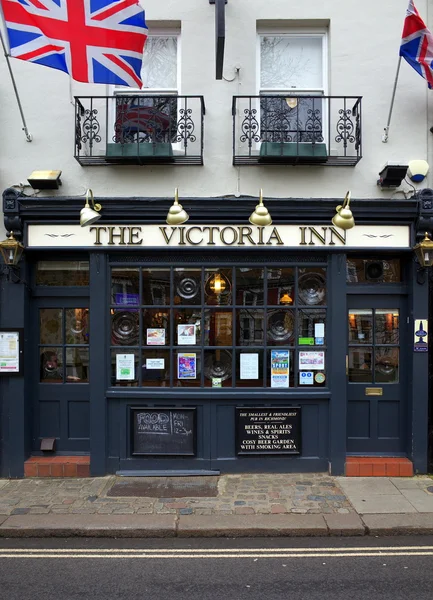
[0,0,433,477]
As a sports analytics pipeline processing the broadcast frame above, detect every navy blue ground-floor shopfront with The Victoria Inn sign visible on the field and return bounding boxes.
[0,190,428,477]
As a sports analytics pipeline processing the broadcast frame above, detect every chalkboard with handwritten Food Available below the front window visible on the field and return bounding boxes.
[131,408,196,456]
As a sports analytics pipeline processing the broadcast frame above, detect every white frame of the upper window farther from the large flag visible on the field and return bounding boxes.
[256,28,330,152]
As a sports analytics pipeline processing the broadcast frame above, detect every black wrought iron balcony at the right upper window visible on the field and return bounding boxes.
[232,95,362,167]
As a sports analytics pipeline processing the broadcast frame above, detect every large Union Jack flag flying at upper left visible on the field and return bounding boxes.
[0,0,147,88]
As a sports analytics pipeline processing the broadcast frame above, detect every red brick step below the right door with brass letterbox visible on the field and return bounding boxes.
[346,456,413,477]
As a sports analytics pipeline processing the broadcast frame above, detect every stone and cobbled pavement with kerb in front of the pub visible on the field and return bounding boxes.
[0,473,433,538]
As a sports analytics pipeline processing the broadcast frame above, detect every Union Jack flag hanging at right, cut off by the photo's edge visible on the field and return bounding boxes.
[400,0,433,88]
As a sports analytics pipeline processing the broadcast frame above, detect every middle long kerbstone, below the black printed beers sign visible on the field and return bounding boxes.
[177,514,329,537]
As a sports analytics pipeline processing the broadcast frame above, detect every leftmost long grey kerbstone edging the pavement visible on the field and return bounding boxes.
[0,514,176,538]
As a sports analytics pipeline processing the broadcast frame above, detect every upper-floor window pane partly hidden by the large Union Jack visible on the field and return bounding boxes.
[141,35,177,89]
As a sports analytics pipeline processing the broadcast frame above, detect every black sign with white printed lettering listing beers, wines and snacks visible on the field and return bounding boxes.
[236,406,301,454]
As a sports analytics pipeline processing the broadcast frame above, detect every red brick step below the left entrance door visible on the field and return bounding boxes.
[24,456,90,477]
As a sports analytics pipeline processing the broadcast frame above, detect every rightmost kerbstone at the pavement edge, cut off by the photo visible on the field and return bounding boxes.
[362,513,433,535]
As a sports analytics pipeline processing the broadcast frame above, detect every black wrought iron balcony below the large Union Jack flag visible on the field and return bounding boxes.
[74,94,205,166]
